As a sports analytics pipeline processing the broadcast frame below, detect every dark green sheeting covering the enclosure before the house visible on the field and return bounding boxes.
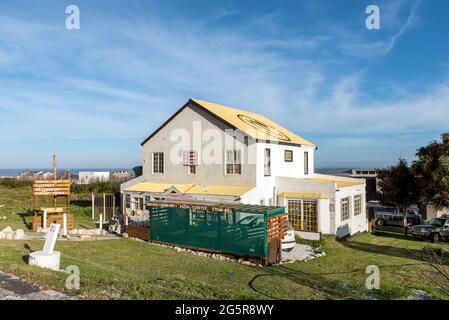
[150,206,284,257]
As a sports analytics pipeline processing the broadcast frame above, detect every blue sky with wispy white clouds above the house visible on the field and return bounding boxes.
[0,0,449,168]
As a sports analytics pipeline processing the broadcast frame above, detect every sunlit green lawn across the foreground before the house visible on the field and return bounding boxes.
[0,229,449,299]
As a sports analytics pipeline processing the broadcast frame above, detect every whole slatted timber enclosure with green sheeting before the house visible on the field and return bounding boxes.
[125,200,288,265]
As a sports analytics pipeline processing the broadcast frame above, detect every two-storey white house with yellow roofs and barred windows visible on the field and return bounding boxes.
[121,99,368,236]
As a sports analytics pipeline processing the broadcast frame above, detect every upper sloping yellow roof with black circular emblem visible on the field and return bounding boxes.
[191,98,316,147]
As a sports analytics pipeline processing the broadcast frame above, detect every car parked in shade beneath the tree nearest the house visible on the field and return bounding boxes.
[374,205,422,227]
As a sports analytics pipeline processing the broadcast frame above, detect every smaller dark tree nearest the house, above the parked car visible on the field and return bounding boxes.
[378,159,419,213]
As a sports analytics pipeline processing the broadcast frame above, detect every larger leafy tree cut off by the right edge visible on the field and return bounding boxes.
[412,132,449,207]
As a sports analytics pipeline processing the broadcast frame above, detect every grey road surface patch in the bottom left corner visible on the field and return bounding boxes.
[0,271,70,300]
